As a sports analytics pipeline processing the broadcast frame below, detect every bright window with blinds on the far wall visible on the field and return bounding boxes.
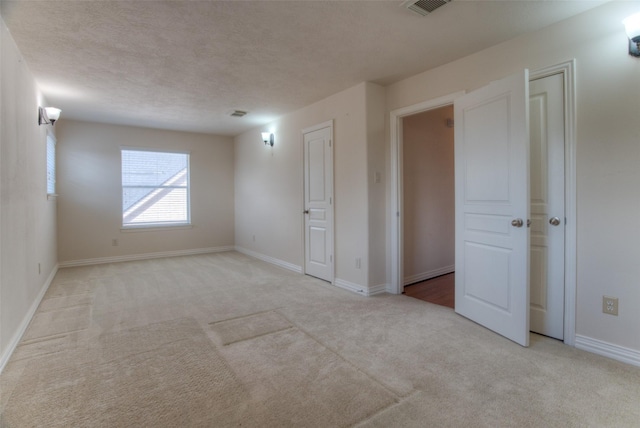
[122,149,191,227]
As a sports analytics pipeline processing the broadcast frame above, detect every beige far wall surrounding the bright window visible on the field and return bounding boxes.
[56,120,234,263]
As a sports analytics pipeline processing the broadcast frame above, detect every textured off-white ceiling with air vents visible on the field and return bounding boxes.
[0,0,602,136]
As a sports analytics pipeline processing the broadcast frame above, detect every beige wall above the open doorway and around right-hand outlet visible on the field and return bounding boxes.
[387,2,640,351]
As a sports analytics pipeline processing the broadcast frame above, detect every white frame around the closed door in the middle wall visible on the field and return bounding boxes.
[300,119,336,285]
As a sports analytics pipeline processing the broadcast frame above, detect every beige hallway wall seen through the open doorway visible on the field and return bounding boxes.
[402,106,455,283]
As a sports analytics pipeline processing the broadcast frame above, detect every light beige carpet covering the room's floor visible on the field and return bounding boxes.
[0,252,640,428]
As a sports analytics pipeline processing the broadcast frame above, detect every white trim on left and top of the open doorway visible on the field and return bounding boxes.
[387,91,465,294]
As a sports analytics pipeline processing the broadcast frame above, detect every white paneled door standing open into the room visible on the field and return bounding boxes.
[454,70,529,346]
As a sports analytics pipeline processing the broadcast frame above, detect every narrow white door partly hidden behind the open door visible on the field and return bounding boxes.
[529,74,565,340]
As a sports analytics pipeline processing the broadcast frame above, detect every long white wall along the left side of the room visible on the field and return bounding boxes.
[0,19,57,370]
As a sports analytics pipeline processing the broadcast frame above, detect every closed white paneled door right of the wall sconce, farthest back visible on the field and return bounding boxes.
[303,123,333,282]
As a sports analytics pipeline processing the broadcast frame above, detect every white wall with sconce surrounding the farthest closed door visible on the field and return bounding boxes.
[235,83,384,290]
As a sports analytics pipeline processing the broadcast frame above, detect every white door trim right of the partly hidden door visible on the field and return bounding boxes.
[529,59,578,346]
